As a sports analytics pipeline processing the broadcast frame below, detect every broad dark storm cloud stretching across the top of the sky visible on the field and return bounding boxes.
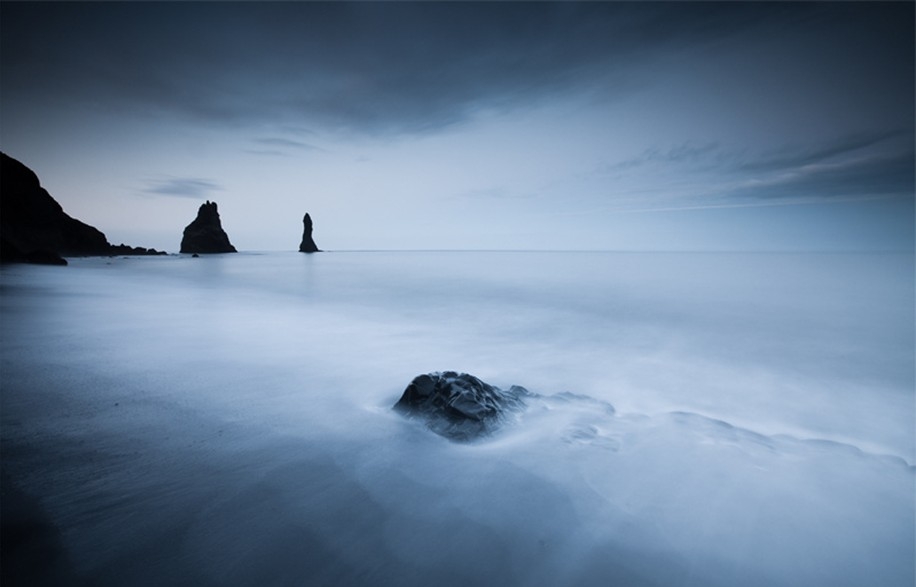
[0,3,811,133]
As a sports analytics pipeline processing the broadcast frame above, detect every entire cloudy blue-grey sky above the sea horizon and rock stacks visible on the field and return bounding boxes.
[0,0,916,252]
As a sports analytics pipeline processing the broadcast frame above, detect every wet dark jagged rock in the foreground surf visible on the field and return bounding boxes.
[394,371,532,441]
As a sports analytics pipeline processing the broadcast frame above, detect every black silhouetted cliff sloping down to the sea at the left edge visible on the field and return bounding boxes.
[0,153,165,265]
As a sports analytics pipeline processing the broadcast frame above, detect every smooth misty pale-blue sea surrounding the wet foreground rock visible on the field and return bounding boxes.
[0,252,916,586]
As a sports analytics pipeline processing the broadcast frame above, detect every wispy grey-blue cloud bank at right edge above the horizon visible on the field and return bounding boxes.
[598,131,916,211]
